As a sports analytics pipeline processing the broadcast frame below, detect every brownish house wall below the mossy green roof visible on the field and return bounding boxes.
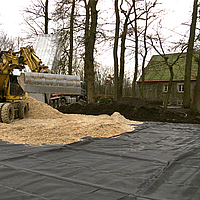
[138,81,196,105]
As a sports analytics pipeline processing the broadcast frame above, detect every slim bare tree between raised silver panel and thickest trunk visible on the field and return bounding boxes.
[53,0,85,74]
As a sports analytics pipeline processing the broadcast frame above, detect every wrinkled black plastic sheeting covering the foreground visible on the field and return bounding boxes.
[0,122,200,200]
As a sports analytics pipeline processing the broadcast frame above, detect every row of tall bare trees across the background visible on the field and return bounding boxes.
[0,0,200,111]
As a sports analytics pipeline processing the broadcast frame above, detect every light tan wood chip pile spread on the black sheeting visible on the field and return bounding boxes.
[0,96,140,145]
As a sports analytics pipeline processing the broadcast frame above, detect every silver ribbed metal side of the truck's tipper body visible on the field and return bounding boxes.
[19,72,81,95]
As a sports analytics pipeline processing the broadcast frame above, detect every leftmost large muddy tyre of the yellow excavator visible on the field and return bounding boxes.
[1,103,15,123]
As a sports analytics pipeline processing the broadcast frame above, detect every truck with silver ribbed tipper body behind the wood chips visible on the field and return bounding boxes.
[23,72,86,108]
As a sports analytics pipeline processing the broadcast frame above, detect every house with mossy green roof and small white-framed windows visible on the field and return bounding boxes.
[137,51,200,105]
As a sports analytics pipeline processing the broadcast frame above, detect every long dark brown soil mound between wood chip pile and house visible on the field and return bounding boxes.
[58,97,200,124]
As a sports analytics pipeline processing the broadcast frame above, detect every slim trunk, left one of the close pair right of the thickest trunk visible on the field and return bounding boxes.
[113,0,120,101]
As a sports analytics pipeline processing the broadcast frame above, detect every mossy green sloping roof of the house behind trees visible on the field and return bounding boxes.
[139,52,199,81]
